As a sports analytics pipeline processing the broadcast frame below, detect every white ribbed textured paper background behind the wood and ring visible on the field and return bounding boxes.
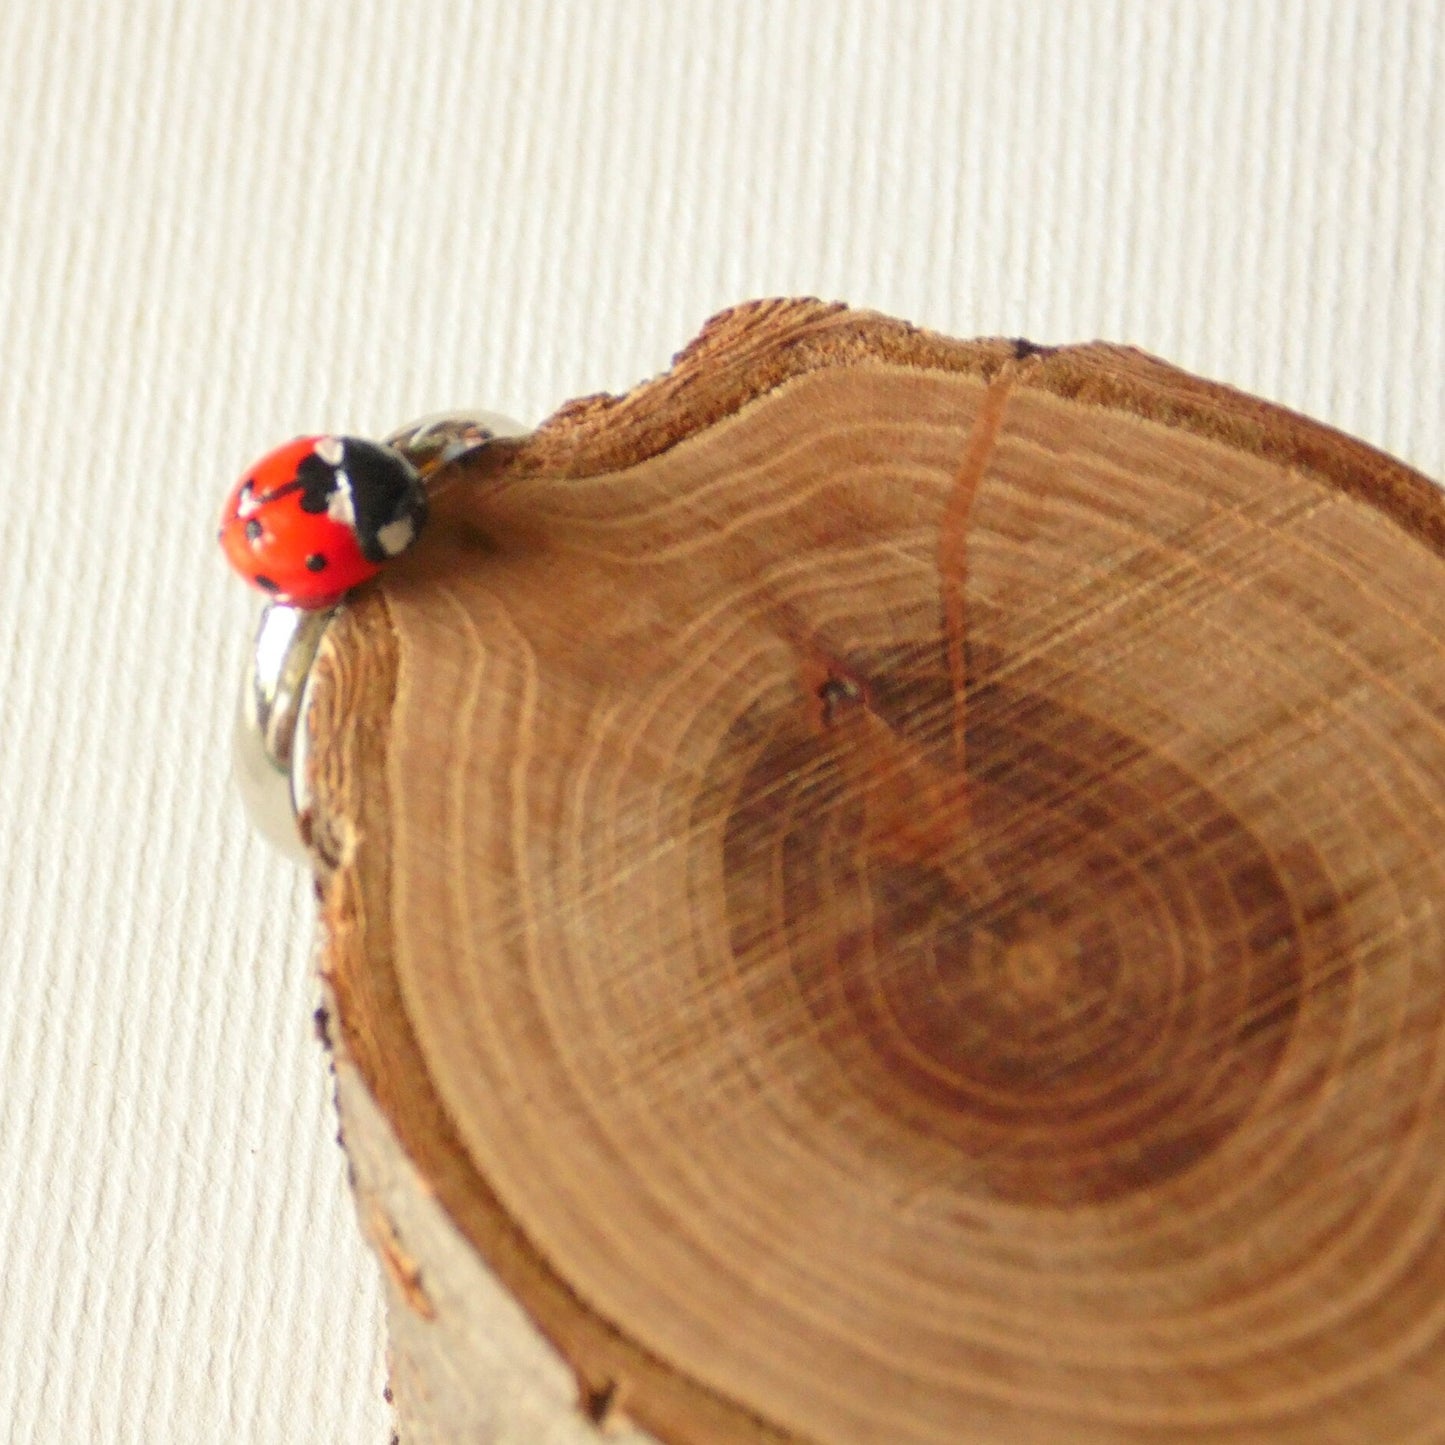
[0,0,1445,1445]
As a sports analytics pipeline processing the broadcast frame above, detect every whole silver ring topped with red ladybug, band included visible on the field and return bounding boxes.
[231,413,526,858]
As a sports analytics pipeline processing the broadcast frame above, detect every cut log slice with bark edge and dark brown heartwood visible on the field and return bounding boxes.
[308,302,1445,1445]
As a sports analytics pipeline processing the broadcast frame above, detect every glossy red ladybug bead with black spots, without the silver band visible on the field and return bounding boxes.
[220,436,426,610]
